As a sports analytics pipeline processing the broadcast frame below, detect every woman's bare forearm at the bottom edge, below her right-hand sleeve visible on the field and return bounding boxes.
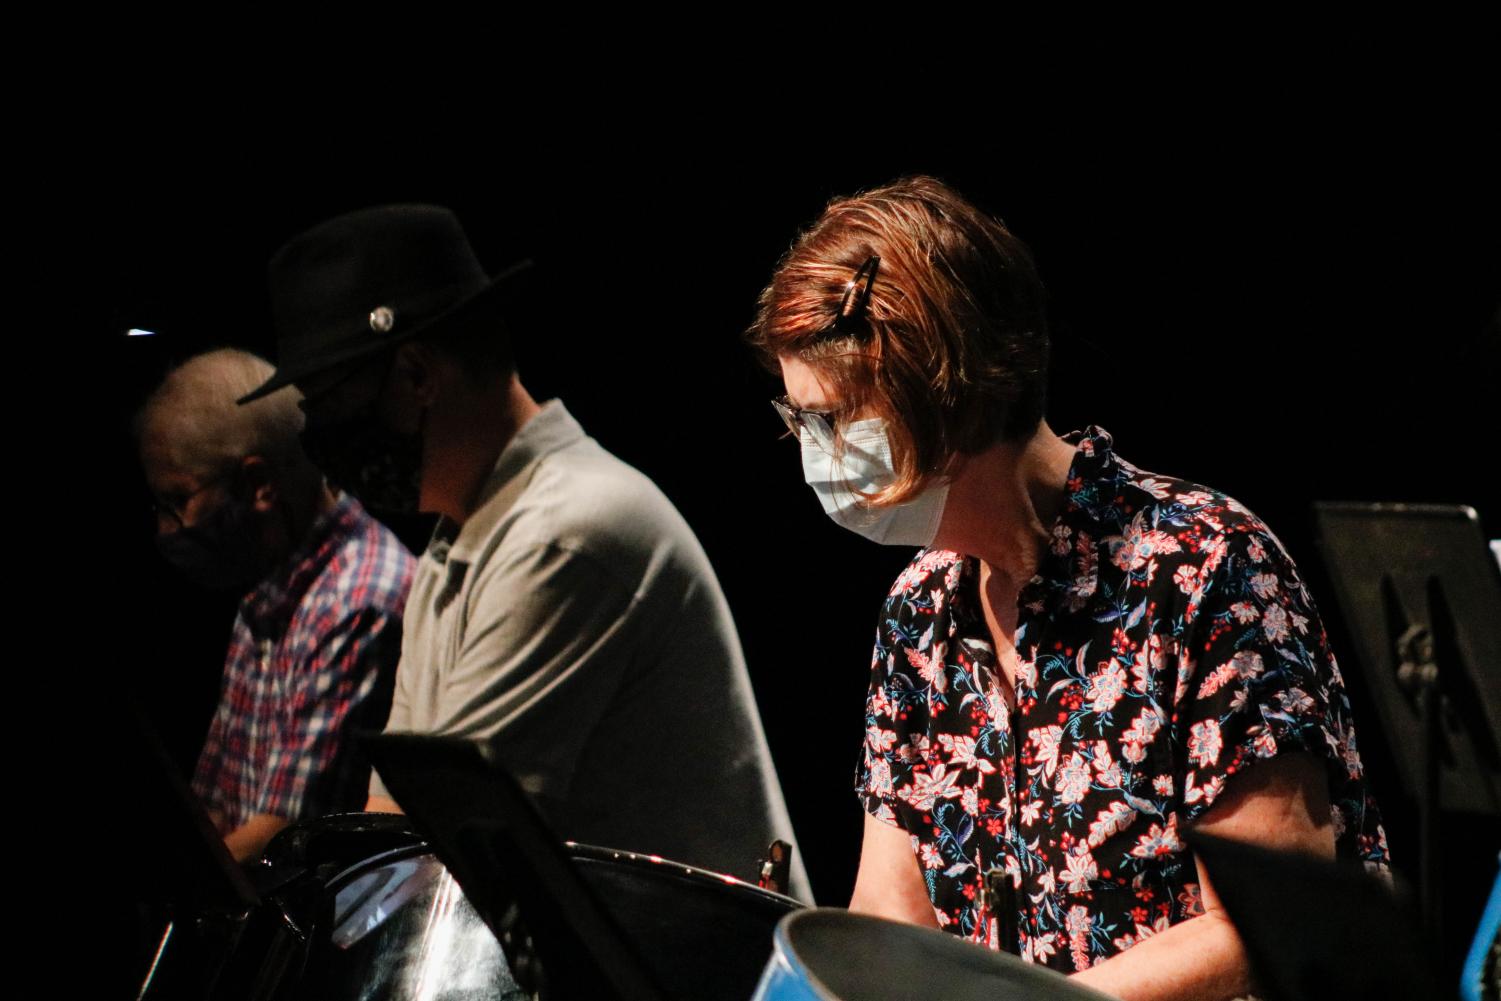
[1073,911,1250,1001]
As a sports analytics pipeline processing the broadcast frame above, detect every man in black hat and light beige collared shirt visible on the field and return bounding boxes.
[246,206,808,896]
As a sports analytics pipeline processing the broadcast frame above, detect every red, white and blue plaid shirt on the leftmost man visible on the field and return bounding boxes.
[192,494,413,833]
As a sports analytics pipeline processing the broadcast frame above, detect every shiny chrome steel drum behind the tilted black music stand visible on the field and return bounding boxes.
[242,815,802,1001]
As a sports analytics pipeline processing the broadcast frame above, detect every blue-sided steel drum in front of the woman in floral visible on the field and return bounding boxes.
[750,908,1109,1001]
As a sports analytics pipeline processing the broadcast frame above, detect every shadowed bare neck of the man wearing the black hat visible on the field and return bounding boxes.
[420,372,542,524]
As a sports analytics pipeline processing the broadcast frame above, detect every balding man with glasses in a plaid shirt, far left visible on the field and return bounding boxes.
[137,350,413,860]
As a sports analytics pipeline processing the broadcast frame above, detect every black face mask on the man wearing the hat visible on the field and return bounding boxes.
[302,404,422,515]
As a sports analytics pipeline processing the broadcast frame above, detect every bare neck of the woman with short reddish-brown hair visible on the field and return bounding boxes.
[935,422,1075,590]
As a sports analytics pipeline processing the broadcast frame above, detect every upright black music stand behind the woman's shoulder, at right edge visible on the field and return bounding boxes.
[1313,503,1501,942]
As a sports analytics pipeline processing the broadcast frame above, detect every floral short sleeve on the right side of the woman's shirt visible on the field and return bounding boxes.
[1174,524,1364,840]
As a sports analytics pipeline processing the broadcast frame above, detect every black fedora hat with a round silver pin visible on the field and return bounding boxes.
[240,206,531,404]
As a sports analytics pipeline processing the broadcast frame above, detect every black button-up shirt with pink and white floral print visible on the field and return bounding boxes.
[857,428,1387,972]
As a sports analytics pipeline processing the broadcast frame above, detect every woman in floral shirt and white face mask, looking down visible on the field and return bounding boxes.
[749,177,1387,998]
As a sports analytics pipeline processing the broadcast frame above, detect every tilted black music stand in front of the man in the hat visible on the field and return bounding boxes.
[362,734,666,1001]
